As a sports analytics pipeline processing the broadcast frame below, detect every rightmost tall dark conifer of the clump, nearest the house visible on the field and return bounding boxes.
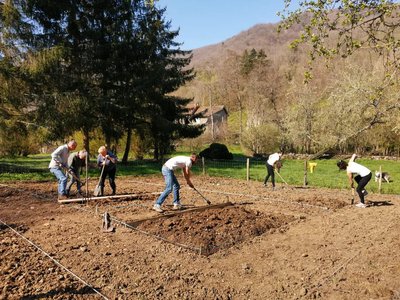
[139,7,203,159]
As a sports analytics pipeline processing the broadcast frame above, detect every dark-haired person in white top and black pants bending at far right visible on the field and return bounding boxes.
[337,154,372,208]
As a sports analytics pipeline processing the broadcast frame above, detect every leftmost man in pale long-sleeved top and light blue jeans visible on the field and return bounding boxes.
[49,140,77,200]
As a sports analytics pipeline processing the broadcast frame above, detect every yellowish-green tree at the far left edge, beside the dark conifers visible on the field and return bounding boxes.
[0,1,47,155]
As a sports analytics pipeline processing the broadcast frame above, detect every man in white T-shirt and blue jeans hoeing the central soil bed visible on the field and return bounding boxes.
[153,153,197,212]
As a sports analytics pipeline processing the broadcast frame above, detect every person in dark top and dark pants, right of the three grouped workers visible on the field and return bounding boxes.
[97,146,118,196]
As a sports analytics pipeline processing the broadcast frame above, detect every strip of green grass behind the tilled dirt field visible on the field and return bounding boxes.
[0,152,400,194]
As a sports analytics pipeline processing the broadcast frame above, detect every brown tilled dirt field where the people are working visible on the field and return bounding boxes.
[0,176,400,299]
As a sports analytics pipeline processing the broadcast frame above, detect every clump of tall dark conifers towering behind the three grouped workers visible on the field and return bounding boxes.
[2,0,202,157]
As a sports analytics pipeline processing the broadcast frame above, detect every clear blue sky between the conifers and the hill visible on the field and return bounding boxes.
[155,0,296,50]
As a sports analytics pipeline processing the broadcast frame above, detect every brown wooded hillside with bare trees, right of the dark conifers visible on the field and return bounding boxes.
[178,14,399,155]
